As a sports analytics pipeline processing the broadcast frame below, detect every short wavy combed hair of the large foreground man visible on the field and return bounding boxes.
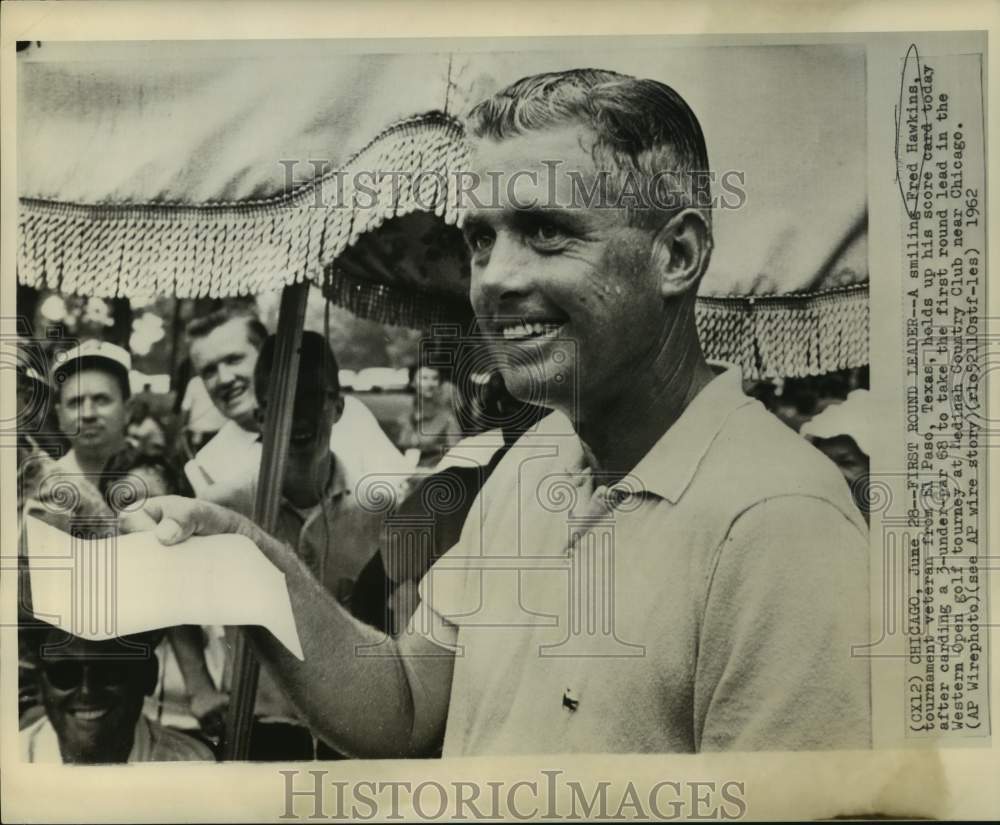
[467,69,711,228]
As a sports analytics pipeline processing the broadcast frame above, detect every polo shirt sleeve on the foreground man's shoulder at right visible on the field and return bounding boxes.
[694,495,871,751]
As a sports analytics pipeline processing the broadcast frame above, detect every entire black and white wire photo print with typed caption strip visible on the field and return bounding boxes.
[2,4,992,821]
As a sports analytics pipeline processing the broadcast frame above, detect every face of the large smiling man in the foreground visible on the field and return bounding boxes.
[462,126,667,415]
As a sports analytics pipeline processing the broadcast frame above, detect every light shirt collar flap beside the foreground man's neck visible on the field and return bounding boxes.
[630,362,753,504]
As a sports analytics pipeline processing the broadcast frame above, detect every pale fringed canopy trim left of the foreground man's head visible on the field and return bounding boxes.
[18,113,467,298]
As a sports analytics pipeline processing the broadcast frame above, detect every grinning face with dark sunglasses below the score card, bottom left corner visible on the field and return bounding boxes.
[39,638,156,763]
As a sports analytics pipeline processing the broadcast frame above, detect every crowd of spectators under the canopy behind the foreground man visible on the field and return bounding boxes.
[18,310,868,763]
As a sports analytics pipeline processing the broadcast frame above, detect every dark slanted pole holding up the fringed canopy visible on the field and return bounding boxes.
[223,281,309,760]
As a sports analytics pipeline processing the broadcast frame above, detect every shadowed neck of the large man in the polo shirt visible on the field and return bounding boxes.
[575,334,715,480]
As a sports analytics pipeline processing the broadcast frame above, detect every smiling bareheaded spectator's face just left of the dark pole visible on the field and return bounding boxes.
[190,318,257,426]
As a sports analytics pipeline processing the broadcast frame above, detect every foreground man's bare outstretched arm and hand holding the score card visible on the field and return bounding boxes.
[132,496,454,757]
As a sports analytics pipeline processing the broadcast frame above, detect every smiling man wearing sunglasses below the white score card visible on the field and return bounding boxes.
[20,625,214,765]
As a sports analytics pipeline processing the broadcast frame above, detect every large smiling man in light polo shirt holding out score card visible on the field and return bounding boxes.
[131,69,870,756]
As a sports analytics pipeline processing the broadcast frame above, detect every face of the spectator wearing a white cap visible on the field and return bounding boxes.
[58,369,128,452]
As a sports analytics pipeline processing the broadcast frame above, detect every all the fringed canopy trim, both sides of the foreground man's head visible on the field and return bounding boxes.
[18,108,868,379]
